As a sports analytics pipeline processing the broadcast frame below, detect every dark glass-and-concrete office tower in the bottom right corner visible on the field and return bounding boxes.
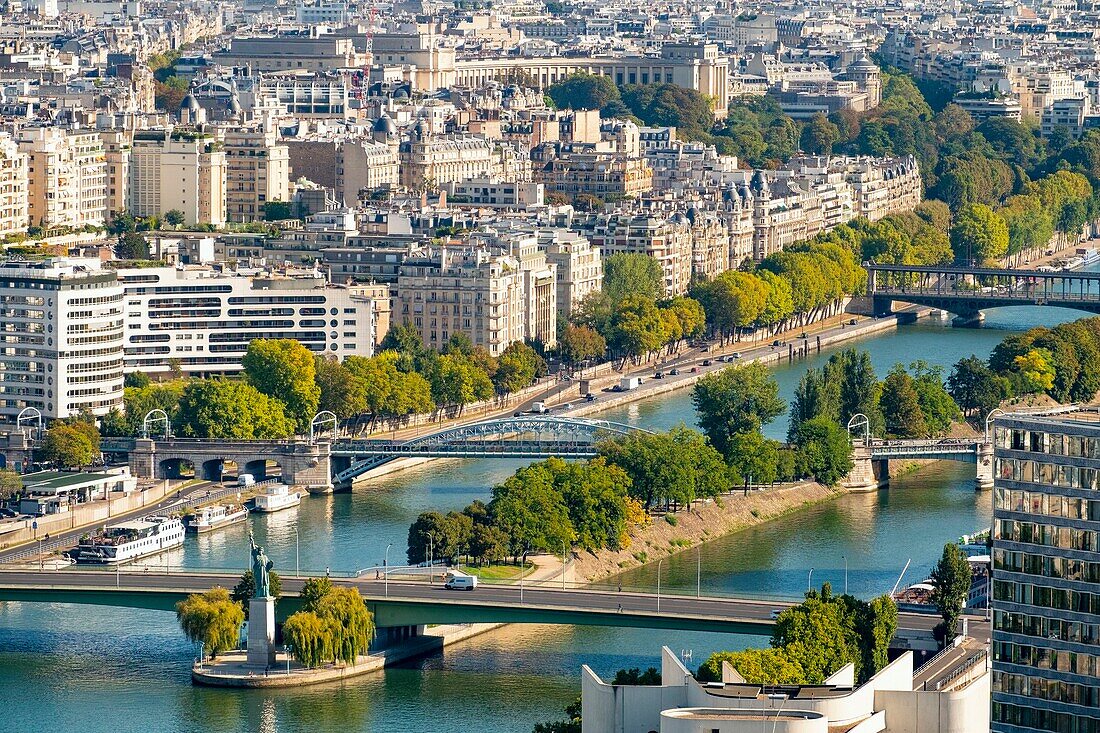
[992,408,1100,733]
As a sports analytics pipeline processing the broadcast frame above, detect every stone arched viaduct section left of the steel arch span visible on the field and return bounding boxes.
[130,438,332,491]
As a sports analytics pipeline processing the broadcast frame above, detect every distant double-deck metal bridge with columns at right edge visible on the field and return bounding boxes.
[864,262,1100,320]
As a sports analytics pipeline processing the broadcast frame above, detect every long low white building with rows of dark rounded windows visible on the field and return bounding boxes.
[118,267,375,375]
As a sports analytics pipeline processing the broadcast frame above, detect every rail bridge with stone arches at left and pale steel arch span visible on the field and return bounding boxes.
[101,415,646,488]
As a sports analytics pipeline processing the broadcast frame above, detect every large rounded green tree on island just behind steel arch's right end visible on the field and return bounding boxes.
[692,363,787,460]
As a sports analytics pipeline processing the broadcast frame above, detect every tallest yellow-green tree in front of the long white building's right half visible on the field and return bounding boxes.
[241,339,321,433]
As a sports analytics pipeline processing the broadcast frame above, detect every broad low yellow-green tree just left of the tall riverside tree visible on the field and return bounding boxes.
[173,379,294,440]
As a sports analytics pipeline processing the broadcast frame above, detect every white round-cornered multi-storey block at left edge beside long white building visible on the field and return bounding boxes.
[0,258,124,422]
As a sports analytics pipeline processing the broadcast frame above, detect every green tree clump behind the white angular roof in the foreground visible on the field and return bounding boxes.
[696,583,898,685]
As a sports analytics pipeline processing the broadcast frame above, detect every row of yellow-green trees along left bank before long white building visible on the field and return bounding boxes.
[97,326,546,445]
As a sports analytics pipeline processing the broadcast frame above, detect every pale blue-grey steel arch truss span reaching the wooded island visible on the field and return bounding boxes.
[331,415,647,485]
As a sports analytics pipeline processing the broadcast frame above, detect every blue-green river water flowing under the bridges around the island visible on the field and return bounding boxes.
[0,308,1081,733]
